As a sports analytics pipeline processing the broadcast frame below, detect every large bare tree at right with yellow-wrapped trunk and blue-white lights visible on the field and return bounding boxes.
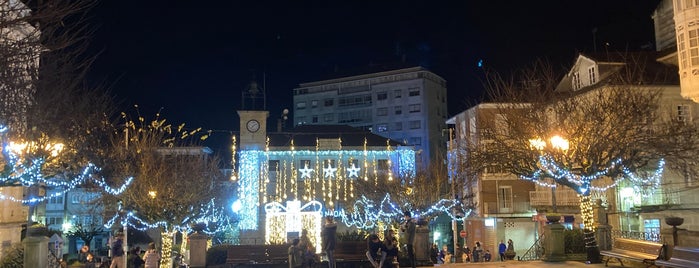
[463,55,697,262]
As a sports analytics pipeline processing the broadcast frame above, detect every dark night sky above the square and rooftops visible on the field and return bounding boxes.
[90,0,659,155]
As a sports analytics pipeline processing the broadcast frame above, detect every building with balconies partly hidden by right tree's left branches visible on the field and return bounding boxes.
[446,103,550,256]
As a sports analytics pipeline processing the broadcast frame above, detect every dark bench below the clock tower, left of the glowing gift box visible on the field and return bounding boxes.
[226,245,289,266]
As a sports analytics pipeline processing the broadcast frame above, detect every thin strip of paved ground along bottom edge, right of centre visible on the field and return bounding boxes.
[425,261,633,268]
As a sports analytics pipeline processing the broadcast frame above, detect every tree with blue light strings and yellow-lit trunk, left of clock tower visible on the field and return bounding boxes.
[102,113,222,265]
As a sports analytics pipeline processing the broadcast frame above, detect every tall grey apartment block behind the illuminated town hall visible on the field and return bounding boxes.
[293,67,447,170]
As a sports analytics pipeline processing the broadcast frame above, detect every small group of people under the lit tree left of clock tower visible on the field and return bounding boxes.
[109,233,160,268]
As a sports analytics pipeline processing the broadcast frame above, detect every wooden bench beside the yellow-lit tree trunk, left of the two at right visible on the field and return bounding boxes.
[600,238,664,267]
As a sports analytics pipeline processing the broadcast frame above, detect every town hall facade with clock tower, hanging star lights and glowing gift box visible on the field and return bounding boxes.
[234,108,415,244]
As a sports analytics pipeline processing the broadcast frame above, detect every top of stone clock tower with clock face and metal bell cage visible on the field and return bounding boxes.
[238,77,269,150]
